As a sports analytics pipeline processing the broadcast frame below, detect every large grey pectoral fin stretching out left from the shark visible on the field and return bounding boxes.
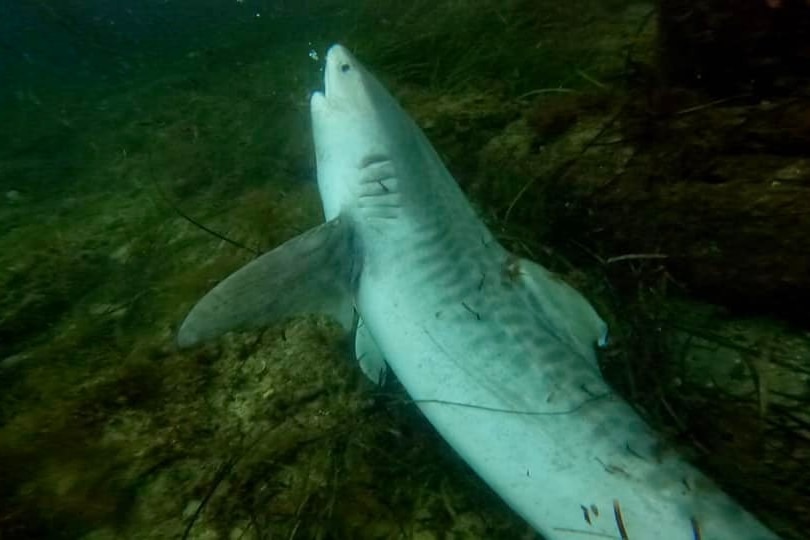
[177,217,358,347]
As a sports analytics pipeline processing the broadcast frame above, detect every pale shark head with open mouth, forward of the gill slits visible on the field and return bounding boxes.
[311,45,424,220]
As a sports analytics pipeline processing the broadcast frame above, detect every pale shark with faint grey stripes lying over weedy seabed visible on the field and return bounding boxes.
[177,45,778,540]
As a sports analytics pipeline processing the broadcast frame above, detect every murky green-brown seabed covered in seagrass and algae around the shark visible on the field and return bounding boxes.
[0,0,810,540]
